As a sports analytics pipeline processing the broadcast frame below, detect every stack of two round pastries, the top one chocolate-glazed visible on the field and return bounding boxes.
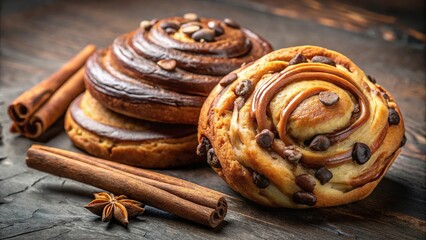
[65,14,271,168]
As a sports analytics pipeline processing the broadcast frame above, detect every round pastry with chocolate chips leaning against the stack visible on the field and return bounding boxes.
[197,46,405,208]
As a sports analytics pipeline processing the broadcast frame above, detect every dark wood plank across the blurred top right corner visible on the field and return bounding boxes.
[218,0,426,45]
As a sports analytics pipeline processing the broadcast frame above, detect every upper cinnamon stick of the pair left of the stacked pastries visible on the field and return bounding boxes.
[8,45,96,125]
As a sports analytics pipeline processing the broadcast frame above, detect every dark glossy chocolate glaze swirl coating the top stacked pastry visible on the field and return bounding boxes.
[86,17,272,107]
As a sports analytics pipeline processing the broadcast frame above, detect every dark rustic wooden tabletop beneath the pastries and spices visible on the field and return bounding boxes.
[0,0,426,239]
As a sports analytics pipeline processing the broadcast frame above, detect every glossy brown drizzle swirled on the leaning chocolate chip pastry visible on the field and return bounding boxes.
[251,63,387,166]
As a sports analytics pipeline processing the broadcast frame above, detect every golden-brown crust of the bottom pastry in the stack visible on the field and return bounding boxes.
[65,92,200,168]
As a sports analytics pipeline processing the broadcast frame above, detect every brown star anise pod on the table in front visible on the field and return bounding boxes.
[84,192,145,226]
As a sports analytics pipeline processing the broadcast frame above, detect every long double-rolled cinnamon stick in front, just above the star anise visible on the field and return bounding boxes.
[27,145,227,227]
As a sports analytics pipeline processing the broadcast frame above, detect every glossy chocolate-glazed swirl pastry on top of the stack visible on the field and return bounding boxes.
[86,14,272,124]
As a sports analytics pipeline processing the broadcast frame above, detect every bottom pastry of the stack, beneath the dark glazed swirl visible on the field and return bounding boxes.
[65,92,201,168]
